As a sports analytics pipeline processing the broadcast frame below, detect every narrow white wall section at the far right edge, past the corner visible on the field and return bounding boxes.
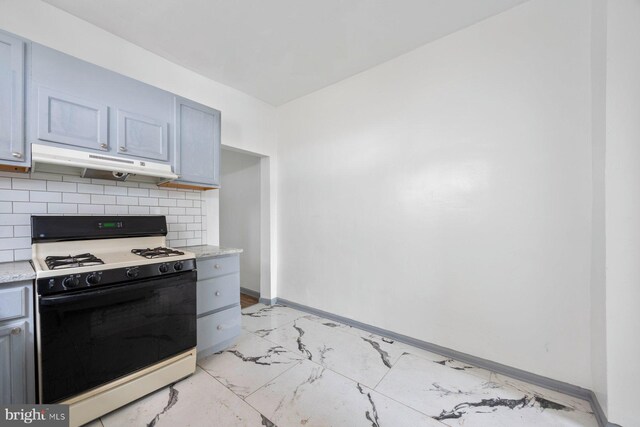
[606,0,640,426]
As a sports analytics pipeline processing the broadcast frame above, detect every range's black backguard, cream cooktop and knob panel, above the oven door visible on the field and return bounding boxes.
[32,216,195,295]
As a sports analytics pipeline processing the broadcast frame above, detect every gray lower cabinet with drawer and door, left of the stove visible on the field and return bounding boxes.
[0,282,35,404]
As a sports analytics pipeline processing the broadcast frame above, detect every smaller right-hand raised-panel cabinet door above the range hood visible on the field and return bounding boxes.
[118,110,169,161]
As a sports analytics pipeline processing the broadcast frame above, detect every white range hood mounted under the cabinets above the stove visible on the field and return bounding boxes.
[31,144,178,184]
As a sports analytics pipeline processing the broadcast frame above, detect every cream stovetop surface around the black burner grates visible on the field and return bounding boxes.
[31,236,195,278]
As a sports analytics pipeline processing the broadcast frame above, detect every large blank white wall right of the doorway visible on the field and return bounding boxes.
[278,0,592,388]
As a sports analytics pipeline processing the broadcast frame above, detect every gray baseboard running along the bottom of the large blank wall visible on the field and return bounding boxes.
[272,298,620,427]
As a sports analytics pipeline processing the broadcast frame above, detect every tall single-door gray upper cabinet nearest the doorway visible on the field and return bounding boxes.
[175,97,220,188]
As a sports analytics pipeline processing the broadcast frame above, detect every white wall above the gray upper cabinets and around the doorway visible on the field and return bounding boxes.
[0,0,276,253]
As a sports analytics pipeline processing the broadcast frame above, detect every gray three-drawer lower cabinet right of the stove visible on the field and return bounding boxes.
[197,254,241,358]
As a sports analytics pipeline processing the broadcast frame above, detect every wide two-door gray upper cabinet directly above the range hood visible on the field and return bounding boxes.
[27,43,174,163]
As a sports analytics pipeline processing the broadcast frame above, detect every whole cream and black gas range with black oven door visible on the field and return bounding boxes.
[31,216,197,427]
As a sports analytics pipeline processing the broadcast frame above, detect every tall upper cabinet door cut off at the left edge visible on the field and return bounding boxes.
[0,33,27,163]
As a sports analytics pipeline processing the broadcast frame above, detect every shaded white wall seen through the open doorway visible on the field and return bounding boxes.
[220,149,261,292]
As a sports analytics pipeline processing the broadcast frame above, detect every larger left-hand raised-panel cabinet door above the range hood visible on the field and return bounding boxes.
[37,86,109,151]
